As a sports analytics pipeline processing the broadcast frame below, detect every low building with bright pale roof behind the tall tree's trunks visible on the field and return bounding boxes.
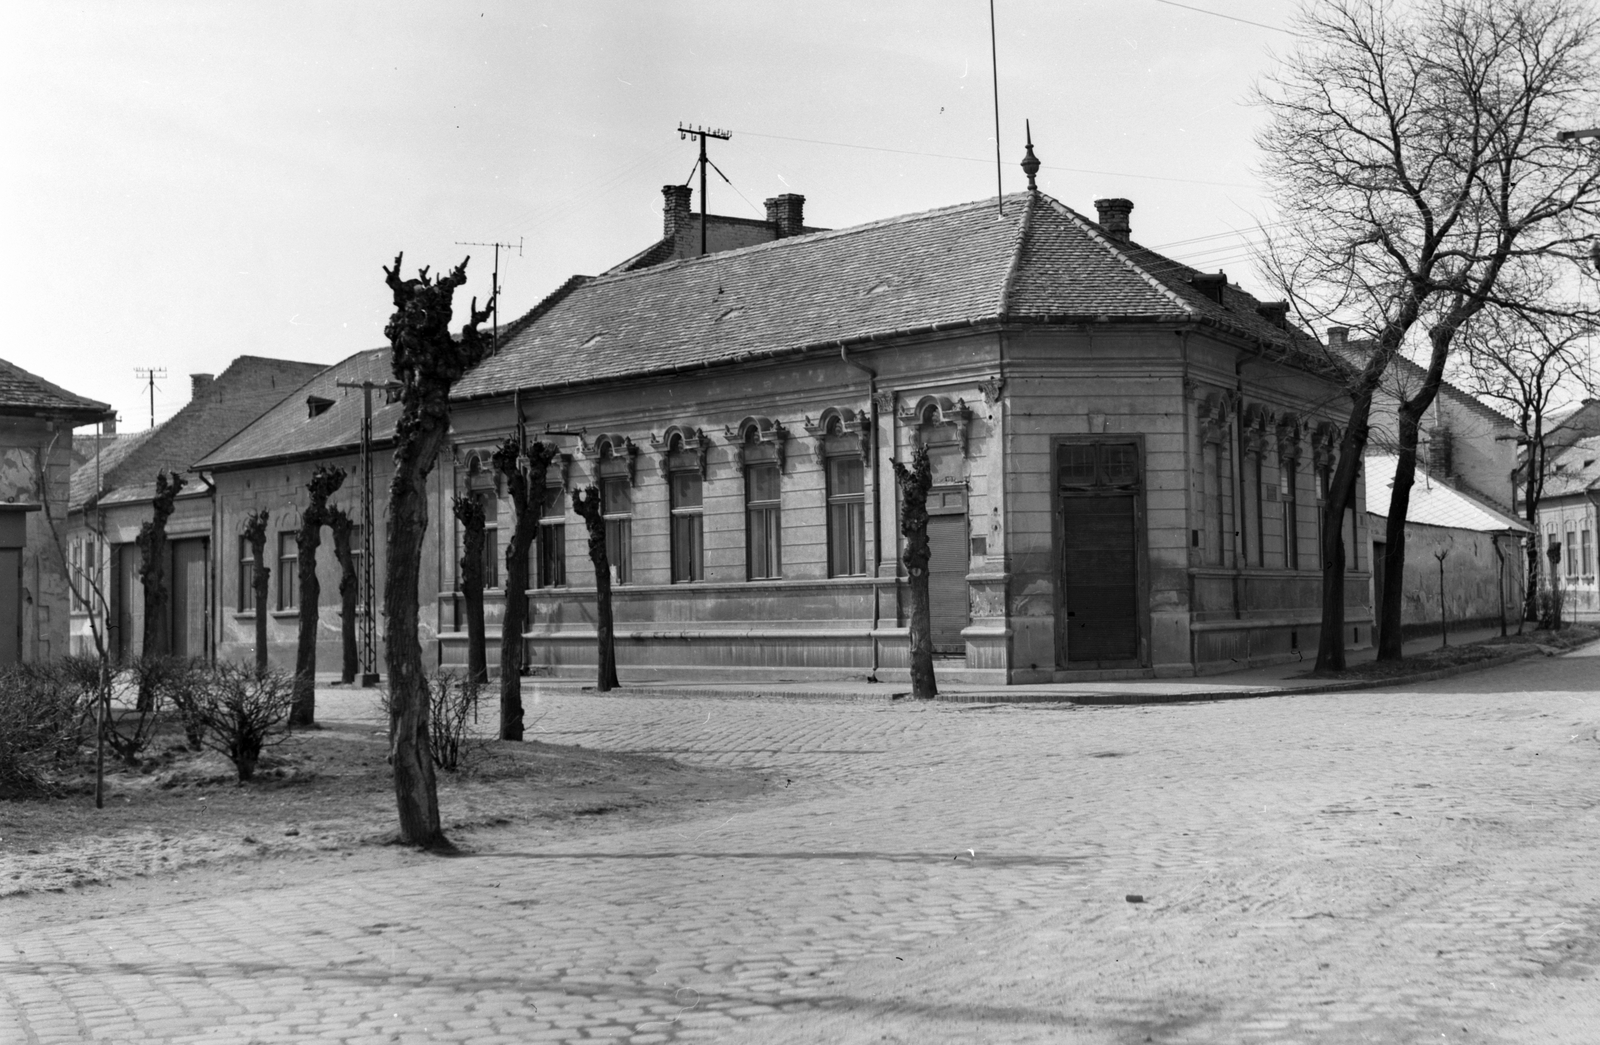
[1365,453,1530,639]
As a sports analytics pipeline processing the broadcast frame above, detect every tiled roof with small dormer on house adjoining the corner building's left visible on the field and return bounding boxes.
[195,347,400,470]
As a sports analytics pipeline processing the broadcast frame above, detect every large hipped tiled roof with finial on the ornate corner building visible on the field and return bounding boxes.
[454,194,1310,398]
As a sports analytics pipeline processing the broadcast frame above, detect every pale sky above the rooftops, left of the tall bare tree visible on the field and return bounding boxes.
[0,0,1296,430]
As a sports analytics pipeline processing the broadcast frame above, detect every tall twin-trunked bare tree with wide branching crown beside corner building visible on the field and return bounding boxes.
[1259,0,1600,669]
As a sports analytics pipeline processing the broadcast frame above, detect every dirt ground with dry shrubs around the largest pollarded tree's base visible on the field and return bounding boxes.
[0,722,766,896]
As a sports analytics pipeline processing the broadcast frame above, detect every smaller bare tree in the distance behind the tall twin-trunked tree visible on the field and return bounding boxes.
[1453,309,1595,621]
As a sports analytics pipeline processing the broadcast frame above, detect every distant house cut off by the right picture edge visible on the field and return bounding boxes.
[1538,435,1600,621]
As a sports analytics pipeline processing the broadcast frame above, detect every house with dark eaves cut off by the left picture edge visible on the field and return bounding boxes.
[0,360,112,666]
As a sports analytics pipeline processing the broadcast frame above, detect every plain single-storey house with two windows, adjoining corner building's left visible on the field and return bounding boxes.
[197,347,432,672]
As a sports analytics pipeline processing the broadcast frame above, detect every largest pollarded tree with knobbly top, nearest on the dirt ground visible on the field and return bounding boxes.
[384,254,494,850]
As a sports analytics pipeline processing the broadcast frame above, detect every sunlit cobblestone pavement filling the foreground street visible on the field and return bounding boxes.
[0,647,1600,1045]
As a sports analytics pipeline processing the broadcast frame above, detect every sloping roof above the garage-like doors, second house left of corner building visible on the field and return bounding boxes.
[72,355,323,507]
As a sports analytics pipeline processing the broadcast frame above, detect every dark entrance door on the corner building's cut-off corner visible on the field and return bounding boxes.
[1058,442,1142,667]
